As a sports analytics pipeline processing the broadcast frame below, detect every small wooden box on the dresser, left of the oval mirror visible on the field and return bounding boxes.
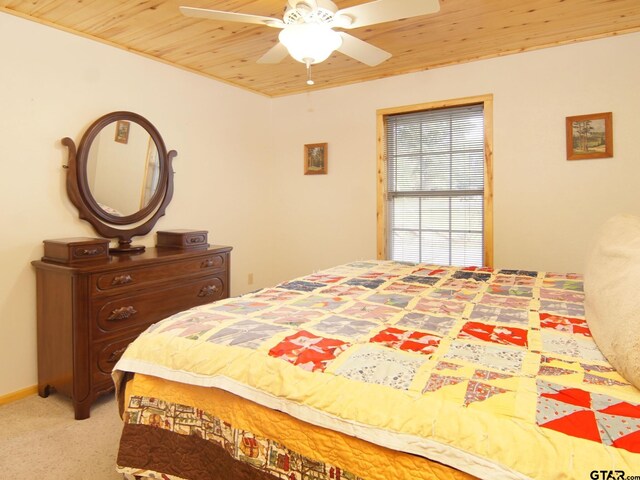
[42,237,109,264]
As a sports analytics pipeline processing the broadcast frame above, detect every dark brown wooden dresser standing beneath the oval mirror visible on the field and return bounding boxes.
[32,239,231,420]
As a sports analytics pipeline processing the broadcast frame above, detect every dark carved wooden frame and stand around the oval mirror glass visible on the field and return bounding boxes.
[62,111,177,253]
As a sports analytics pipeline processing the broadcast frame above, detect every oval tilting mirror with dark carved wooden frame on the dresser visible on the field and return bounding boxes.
[62,112,176,252]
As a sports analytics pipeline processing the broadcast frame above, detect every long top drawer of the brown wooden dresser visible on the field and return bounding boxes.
[91,253,228,295]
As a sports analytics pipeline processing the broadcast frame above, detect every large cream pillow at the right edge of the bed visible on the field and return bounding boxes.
[584,214,640,388]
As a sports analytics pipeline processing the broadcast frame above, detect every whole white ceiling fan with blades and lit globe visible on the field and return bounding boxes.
[180,0,440,85]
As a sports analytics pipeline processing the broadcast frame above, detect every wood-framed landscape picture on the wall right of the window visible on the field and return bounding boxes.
[567,112,613,160]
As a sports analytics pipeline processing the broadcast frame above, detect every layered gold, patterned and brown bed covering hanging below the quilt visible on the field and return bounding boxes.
[117,375,474,480]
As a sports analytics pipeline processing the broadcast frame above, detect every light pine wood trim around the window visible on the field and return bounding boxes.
[376,94,493,267]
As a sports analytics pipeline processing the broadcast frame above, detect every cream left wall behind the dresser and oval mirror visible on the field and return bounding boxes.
[0,14,272,395]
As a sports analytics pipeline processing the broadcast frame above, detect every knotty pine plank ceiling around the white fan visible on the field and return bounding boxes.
[0,0,640,97]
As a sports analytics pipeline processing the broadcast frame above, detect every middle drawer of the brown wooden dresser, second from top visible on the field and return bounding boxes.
[91,272,229,339]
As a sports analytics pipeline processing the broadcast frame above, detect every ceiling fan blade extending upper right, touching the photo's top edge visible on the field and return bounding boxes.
[336,0,440,28]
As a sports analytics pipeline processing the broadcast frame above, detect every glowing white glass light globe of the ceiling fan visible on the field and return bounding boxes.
[278,23,342,64]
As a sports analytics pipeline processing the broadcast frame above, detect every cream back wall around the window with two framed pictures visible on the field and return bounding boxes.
[273,34,640,280]
